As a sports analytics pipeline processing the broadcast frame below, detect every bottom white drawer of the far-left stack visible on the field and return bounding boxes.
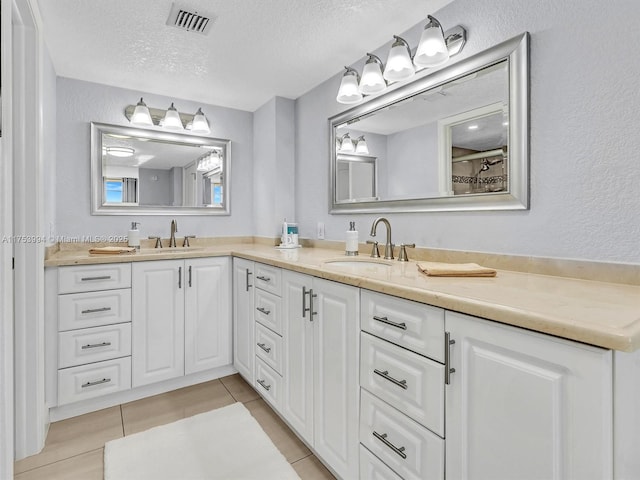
[58,357,131,405]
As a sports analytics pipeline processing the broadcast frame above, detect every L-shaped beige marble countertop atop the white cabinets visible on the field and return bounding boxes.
[45,243,640,352]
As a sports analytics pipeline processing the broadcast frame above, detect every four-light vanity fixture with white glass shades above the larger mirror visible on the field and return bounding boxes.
[336,15,467,105]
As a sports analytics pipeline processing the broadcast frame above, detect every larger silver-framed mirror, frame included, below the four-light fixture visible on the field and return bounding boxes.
[329,33,529,213]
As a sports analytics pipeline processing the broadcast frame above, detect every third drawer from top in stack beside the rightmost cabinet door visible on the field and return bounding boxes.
[360,390,444,480]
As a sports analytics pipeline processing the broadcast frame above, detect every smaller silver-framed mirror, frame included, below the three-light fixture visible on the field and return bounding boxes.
[91,123,231,215]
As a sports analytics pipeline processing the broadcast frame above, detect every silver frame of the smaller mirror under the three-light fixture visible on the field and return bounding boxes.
[91,122,231,215]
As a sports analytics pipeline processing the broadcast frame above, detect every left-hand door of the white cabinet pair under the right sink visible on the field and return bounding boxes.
[282,270,313,443]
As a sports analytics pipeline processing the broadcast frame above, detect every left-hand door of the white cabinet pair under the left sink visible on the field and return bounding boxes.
[131,260,184,387]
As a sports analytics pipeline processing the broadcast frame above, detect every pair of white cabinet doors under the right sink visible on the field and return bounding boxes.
[281,270,360,479]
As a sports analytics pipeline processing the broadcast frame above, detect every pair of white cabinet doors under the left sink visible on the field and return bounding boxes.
[132,257,231,387]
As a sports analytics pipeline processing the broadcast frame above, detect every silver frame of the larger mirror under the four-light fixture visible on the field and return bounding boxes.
[329,32,529,214]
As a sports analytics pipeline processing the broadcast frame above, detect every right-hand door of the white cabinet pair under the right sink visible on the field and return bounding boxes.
[312,278,360,478]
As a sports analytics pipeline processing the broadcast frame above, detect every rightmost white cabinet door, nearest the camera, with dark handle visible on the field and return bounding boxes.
[445,312,613,480]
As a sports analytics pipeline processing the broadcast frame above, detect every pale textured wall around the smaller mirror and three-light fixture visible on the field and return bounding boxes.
[55,77,253,238]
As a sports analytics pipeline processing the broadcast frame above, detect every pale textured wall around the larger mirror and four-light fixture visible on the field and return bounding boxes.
[296,0,640,263]
